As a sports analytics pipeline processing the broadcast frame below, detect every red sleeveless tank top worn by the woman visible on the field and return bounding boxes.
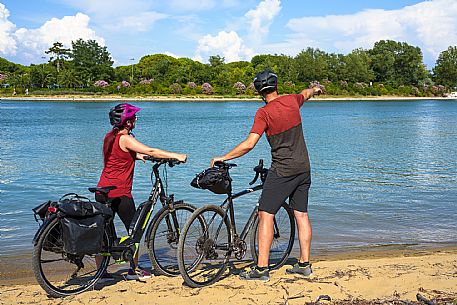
[97,134,136,198]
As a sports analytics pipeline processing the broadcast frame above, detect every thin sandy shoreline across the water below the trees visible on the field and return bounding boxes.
[0,95,457,102]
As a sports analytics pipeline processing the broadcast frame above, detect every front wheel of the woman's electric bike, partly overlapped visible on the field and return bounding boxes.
[146,203,197,276]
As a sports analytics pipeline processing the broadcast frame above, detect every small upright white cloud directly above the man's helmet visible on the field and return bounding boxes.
[245,0,281,44]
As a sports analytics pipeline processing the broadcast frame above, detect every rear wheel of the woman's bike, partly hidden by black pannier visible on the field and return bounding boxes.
[32,217,110,297]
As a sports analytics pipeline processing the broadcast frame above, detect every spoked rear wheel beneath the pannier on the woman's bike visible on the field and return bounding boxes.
[32,217,110,297]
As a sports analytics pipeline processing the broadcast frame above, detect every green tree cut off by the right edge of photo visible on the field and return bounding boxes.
[433,46,457,88]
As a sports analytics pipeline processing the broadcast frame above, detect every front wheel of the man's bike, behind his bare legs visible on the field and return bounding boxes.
[250,202,295,270]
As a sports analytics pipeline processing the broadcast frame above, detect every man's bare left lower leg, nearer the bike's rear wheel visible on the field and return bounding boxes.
[257,211,275,267]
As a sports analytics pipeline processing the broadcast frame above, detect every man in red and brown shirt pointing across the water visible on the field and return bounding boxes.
[211,70,322,281]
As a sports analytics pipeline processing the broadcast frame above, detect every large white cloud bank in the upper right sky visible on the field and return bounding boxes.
[282,0,457,64]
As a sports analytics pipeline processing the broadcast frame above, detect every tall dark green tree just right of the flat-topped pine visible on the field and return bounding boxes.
[70,39,114,86]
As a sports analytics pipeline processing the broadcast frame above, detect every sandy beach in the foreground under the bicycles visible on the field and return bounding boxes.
[0,247,457,305]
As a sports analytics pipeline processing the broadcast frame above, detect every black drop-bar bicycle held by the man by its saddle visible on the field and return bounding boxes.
[178,160,295,288]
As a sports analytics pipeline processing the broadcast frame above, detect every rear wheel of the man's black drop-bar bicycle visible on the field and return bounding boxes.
[178,205,232,288]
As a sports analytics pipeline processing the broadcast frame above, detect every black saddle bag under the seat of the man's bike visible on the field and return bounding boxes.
[190,167,232,194]
